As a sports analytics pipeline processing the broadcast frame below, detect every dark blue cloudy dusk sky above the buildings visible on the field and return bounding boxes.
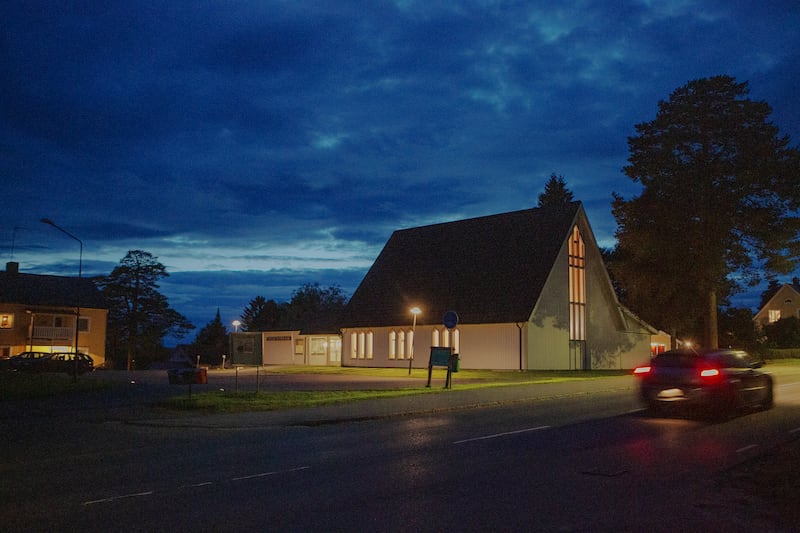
[0,0,800,336]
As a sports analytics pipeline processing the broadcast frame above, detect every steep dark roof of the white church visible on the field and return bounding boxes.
[342,202,585,327]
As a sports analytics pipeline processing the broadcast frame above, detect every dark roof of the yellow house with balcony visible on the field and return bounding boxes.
[0,272,108,309]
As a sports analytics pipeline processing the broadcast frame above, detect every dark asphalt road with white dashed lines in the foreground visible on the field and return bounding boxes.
[0,368,800,531]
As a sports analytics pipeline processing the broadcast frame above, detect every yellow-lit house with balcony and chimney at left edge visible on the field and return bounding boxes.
[0,261,108,367]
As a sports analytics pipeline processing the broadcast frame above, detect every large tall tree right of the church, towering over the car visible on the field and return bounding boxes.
[612,76,800,347]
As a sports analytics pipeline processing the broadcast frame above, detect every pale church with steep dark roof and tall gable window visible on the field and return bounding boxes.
[342,202,669,370]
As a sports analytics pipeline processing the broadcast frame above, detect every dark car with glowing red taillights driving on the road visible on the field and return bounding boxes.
[633,350,773,416]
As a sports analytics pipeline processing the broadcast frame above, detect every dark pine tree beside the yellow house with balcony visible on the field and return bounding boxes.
[98,250,194,370]
